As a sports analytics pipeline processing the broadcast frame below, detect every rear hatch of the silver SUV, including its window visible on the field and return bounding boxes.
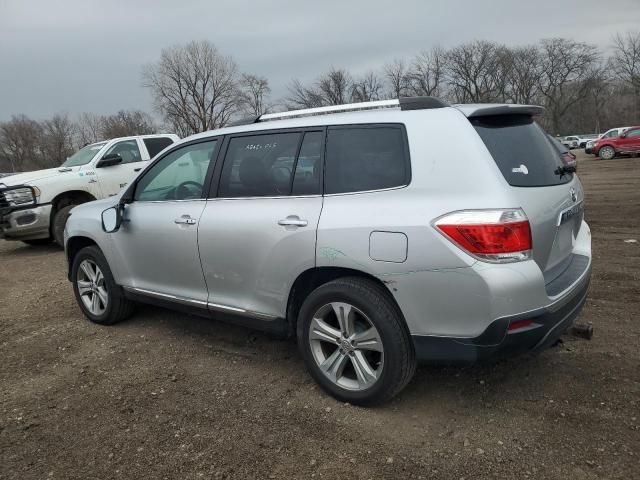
[469,109,584,283]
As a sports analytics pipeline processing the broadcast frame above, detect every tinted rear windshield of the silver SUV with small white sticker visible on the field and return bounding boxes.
[469,115,572,187]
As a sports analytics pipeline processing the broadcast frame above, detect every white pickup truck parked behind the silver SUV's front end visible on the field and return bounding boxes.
[0,134,179,245]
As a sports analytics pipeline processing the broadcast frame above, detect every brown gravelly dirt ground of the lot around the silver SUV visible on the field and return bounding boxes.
[0,151,640,480]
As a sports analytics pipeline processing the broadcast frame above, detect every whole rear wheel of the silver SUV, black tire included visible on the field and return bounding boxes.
[297,277,416,405]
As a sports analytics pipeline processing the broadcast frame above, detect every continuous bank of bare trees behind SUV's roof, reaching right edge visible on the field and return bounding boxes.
[285,32,640,135]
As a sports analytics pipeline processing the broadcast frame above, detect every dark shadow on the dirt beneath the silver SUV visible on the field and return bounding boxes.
[107,305,584,408]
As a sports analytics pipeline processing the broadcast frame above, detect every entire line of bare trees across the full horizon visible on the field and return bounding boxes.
[0,32,640,172]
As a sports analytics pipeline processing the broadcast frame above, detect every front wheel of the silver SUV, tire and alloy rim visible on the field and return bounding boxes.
[71,246,133,325]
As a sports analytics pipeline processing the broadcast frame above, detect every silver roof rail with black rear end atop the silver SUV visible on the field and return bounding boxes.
[252,97,450,125]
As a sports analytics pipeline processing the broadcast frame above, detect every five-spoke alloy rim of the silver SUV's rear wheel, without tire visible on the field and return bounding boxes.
[308,302,384,391]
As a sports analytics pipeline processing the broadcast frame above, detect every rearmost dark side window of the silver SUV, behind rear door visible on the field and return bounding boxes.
[325,125,410,194]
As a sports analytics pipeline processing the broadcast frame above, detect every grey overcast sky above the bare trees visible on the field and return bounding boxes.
[0,0,640,121]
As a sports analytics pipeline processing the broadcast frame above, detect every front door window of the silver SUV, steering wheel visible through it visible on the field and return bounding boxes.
[134,140,218,202]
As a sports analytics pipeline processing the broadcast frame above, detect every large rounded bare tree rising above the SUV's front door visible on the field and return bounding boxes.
[142,41,242,136]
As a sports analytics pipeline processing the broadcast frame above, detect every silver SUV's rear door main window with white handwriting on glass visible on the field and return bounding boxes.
[218,133,301,198]
